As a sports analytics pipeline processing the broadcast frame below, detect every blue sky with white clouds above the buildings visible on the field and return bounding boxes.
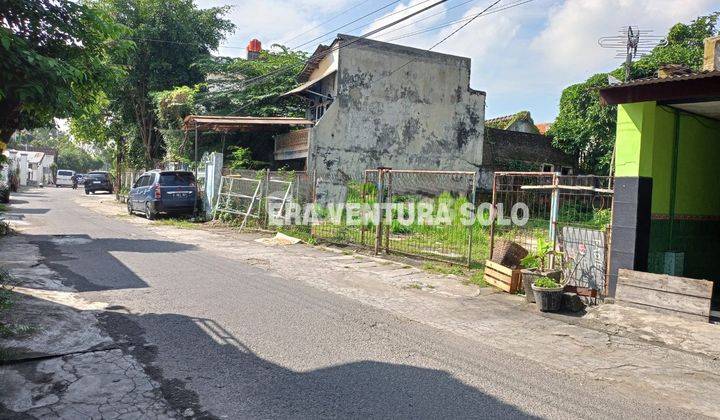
[196,0,720,123]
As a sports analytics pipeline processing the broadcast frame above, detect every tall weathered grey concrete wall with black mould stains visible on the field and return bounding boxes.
[308,36,485,179]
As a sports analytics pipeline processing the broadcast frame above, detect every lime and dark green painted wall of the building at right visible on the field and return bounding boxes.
[615,102,720,285]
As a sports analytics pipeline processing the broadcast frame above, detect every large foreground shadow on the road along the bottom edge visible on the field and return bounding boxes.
[100,312,530,418]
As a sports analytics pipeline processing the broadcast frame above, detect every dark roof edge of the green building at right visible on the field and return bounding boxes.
[600,71,720,105]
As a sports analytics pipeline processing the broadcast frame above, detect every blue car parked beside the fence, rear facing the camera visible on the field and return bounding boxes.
[127,170,198,220]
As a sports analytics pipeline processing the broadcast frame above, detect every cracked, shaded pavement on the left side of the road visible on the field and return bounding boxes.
[0,210,181,419]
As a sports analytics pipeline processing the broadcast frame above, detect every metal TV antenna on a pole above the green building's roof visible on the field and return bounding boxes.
[598,26,667,82]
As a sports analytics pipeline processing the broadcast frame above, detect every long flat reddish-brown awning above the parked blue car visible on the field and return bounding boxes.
[183,115,314,132]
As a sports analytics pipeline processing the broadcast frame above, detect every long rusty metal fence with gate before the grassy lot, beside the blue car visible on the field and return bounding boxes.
[215,169,480,264]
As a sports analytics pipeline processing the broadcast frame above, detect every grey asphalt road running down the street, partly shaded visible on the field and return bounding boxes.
[11,188,686,419]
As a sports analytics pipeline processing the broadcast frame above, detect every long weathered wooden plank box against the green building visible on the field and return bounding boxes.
[615,269,713,322]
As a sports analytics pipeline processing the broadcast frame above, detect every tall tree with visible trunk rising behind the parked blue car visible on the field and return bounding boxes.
[100,0,234,164]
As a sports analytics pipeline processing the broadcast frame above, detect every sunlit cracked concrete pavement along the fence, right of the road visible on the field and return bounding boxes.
[78,195,720,417]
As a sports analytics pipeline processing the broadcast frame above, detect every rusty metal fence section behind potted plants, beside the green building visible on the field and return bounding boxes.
[490,172,613,293]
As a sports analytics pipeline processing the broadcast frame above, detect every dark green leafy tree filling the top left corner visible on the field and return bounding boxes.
[0,0,128,149]
